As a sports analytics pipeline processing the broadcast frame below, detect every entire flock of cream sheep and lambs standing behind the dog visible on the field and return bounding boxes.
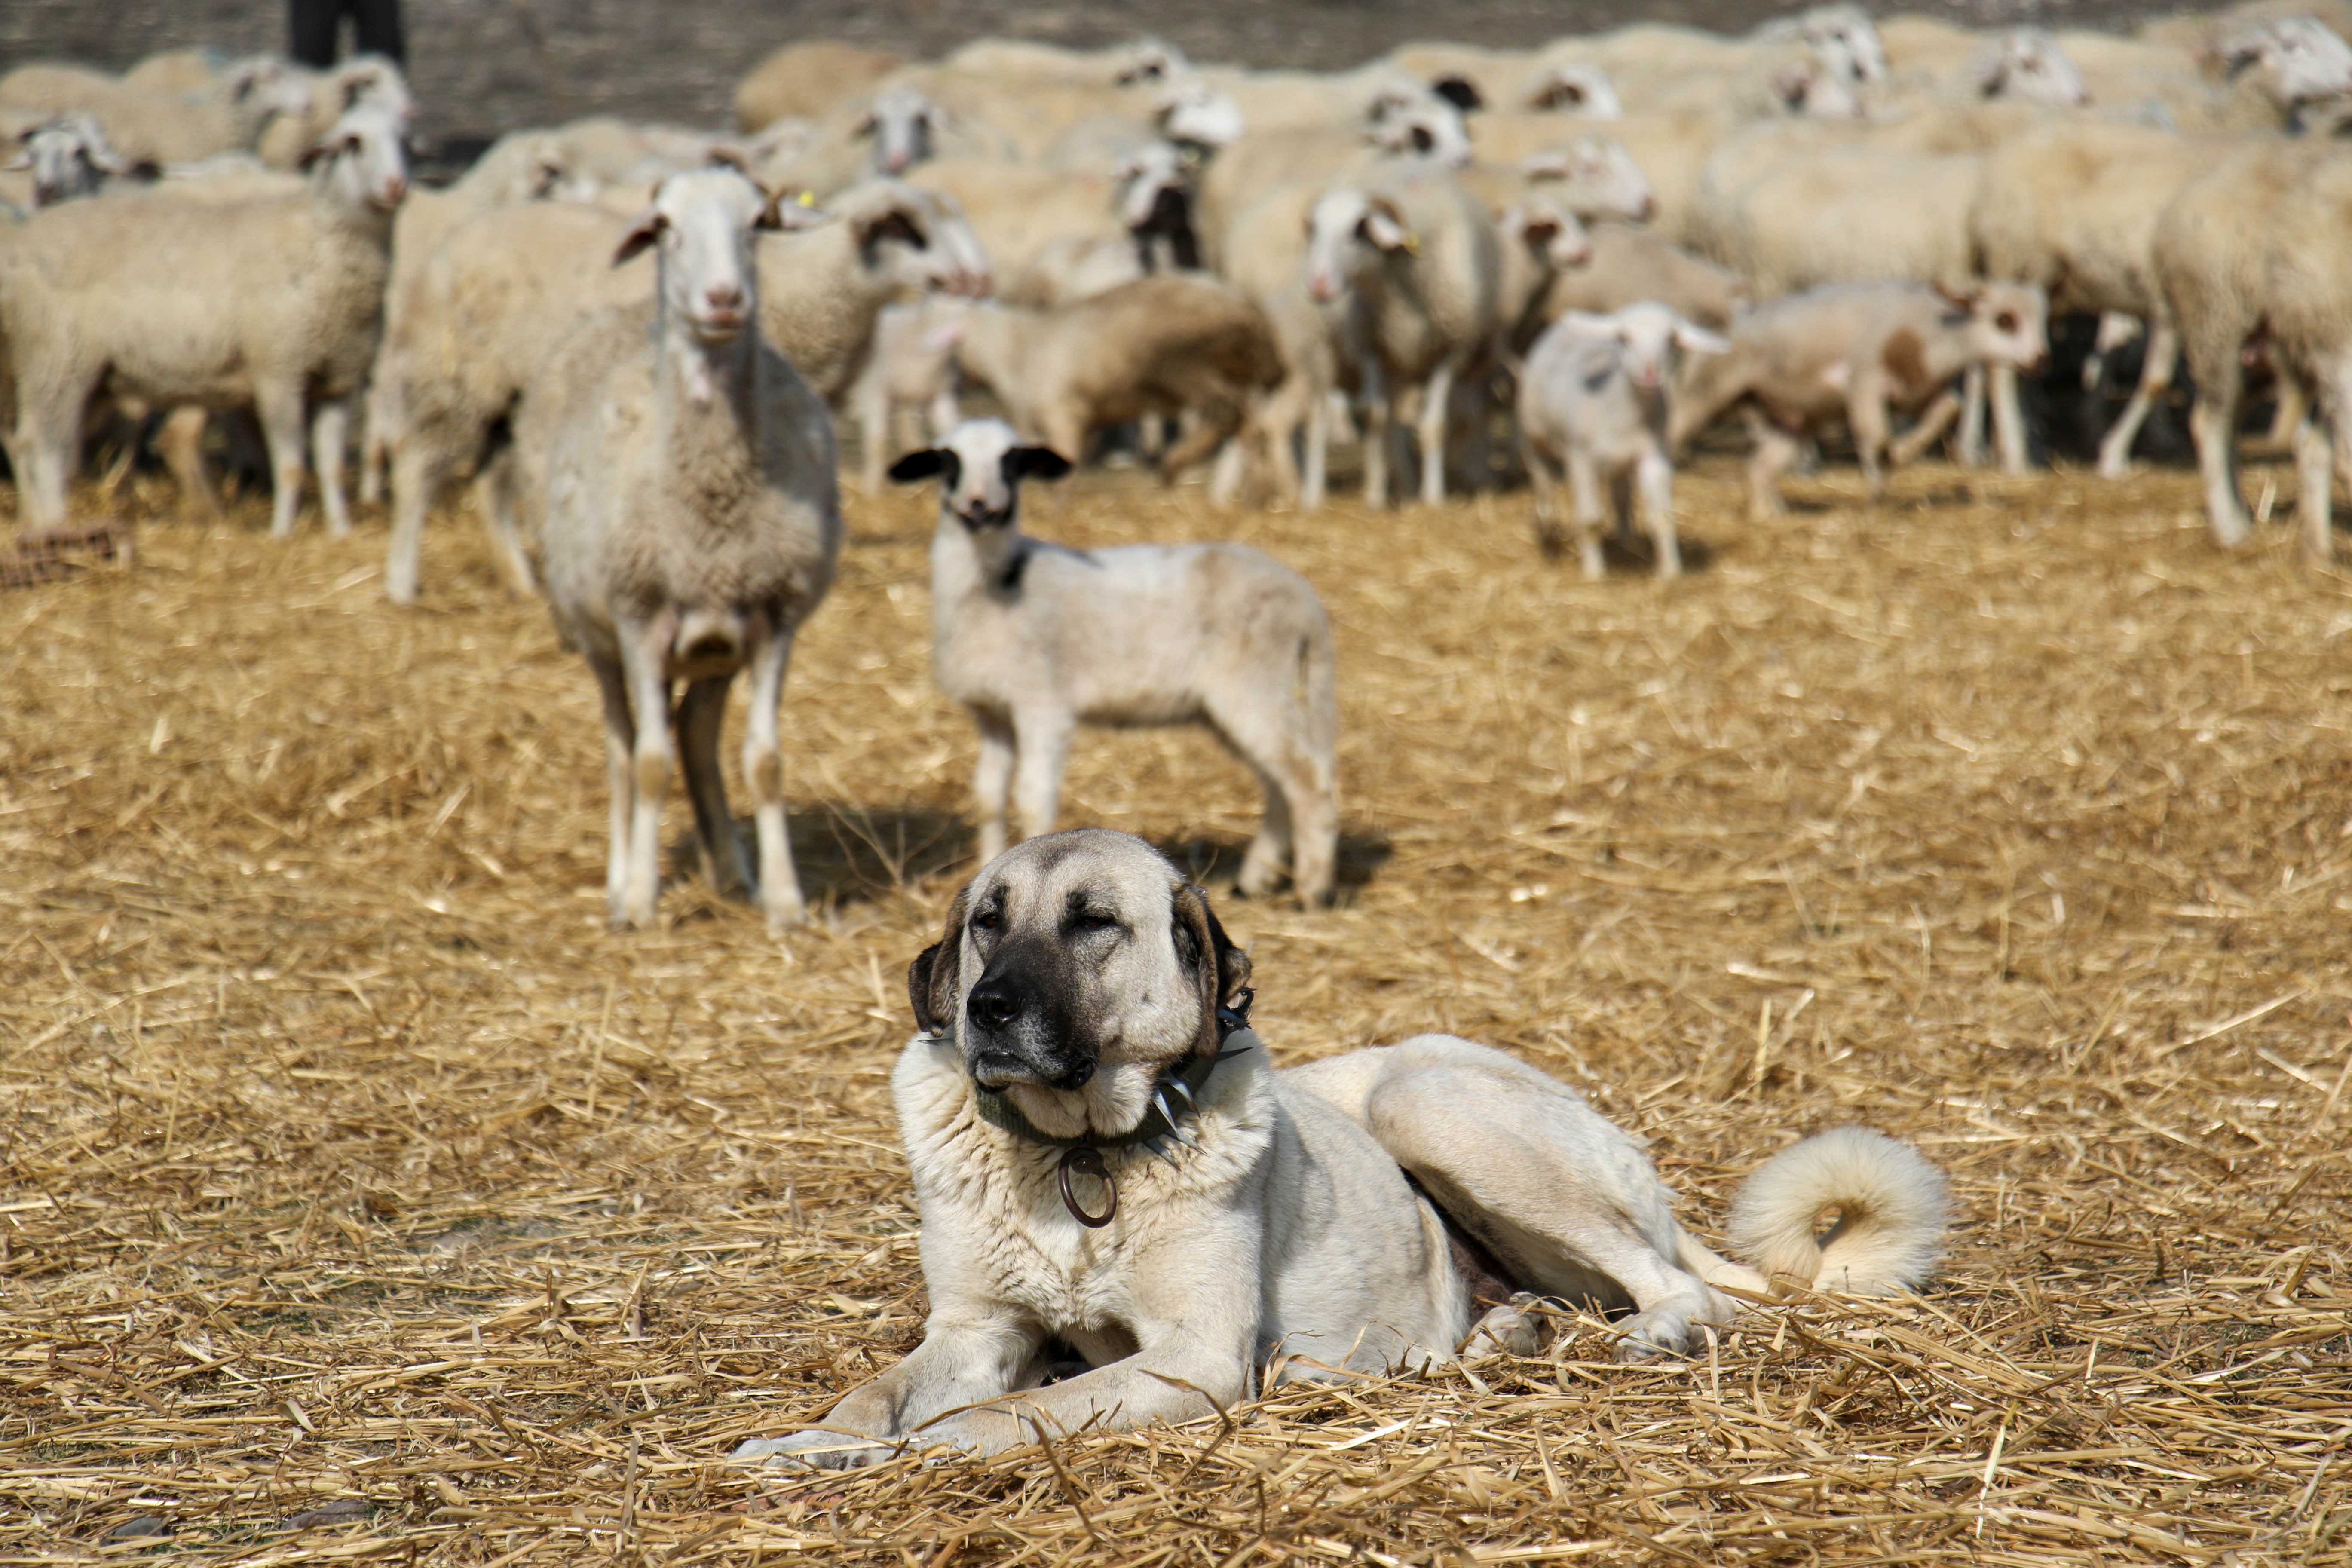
[0,0,2352,924]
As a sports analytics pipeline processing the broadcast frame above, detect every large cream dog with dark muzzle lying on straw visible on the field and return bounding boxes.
[736,827,1945,1467]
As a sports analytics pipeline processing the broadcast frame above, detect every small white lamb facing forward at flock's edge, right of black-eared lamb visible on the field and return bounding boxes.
[1519,301,1731,578]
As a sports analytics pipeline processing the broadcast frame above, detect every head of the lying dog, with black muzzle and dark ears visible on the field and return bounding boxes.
[906,827,1249,1138]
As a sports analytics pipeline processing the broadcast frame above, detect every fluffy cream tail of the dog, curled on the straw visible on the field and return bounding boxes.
[1731,1126,1950,1295]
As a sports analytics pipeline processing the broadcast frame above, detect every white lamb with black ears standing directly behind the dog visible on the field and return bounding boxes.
[889,419,1338,905]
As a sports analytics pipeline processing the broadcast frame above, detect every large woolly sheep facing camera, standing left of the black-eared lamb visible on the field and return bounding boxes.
[515,169,842,926]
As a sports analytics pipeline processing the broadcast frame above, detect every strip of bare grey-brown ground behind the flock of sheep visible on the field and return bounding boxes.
[0,0,2164,141]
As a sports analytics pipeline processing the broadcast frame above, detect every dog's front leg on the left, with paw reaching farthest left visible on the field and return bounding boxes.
[734,1309,1044,1469]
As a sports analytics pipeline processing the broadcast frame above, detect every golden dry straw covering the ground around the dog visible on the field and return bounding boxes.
[0,447,2352,1568]
